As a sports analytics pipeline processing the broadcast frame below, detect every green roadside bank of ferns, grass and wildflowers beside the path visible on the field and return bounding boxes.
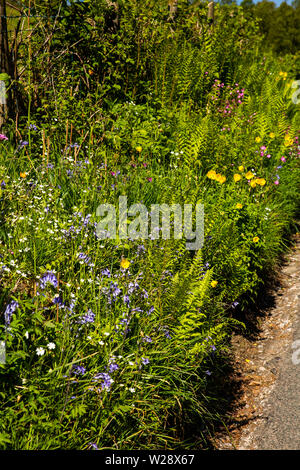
[0,0,300,449]
